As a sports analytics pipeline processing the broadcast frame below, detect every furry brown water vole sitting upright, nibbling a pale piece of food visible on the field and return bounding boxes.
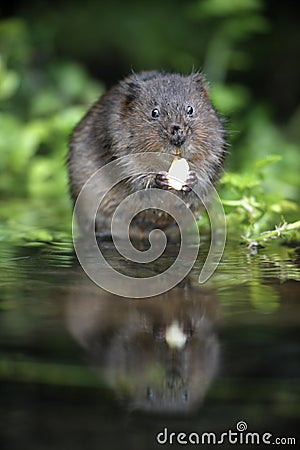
[68,72,225,239]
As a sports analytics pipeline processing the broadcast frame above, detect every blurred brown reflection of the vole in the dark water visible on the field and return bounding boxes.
[66,281,219,413]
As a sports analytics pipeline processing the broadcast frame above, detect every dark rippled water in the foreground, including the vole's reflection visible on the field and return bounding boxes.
[0,237,300,450]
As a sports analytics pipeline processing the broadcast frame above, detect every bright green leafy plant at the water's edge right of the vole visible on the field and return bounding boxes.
[221,155,300,244]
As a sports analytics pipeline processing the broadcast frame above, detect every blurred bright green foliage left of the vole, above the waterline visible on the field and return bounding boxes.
[0,20,101,199]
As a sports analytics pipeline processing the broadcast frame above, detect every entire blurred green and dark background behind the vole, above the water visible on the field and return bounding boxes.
[0,0,300,240]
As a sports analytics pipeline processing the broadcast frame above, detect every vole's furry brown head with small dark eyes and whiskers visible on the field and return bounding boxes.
[121,72,224,165]
